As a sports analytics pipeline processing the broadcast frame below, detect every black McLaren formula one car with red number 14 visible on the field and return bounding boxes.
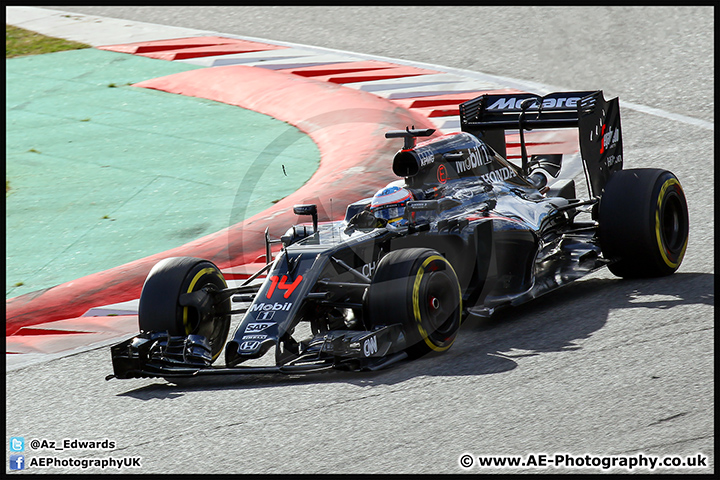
[108,91,689,378]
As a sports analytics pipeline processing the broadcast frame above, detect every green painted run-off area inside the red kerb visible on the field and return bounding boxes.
[5,49,320,298]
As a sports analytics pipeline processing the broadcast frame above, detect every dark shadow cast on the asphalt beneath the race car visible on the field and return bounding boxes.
[119,273,715,400]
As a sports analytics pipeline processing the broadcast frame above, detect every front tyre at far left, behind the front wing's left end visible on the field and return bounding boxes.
[138,257,230,361]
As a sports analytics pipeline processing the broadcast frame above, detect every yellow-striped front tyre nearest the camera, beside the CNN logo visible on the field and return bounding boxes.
[366,248,462,358]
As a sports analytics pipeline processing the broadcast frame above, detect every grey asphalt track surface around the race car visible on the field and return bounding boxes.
[6,7,714,473]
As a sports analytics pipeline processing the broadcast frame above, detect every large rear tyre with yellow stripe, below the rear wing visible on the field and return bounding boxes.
[598,168,689,278]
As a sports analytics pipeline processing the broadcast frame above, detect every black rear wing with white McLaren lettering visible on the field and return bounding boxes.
[460,90,623,196]
